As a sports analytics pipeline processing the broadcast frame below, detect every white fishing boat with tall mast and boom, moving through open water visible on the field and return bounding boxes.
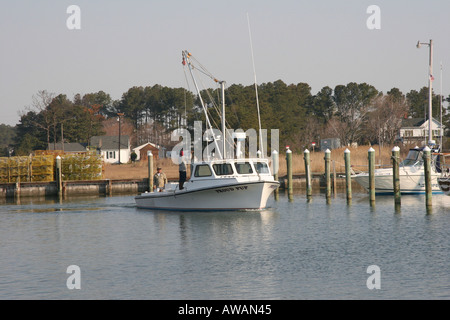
[135,51,280,211]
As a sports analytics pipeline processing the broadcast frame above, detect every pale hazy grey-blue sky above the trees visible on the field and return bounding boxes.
[0,0,450,125]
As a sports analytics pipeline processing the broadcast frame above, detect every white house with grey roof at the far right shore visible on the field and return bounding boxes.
[399,118,445,144]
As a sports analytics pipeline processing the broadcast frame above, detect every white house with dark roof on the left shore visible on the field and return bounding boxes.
[90,135,131,163]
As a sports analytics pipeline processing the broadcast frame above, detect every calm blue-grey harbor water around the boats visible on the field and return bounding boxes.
[0,193,450,300]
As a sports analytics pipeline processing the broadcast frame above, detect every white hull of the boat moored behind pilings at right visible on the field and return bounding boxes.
[352,171,442,194]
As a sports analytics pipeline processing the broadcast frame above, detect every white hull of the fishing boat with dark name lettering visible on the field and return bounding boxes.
[135,181,279,211]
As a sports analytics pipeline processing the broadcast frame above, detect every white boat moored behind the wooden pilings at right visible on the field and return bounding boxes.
[352,147,442,194]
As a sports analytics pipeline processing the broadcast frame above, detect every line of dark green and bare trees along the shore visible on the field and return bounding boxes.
[0,80,450,155]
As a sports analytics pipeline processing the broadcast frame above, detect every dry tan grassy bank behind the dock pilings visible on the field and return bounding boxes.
[104,146,408,180]
